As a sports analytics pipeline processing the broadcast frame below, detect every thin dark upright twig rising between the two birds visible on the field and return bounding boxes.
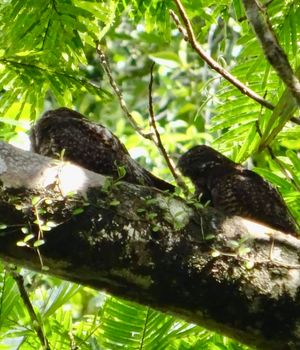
[149,62,189,195]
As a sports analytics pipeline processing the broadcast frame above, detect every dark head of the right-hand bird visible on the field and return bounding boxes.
[178,145,237,180]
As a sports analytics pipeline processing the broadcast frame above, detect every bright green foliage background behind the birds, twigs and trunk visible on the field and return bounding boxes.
[0,0,300,349]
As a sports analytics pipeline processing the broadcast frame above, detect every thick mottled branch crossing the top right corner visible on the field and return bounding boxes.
[243,0,300,106]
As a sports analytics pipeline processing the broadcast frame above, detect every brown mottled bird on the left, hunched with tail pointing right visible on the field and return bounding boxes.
[30,107,175,192]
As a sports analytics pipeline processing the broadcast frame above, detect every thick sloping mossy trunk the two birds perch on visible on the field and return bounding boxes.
[0,143,300,350]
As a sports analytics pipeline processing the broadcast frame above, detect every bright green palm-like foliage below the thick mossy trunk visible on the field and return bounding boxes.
[0,271,251,350]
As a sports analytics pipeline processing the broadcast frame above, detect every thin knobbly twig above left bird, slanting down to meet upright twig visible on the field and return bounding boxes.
[96,42,152,140]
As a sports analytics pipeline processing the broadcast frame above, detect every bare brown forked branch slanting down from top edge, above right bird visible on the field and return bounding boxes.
[170,0,274,109]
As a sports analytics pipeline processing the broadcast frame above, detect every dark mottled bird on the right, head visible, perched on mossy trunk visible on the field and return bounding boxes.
[178,145,297,236]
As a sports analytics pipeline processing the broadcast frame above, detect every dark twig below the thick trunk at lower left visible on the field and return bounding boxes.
[11,271,50,350]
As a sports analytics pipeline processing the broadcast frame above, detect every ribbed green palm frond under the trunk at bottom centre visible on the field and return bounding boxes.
[100,298,201,349]
